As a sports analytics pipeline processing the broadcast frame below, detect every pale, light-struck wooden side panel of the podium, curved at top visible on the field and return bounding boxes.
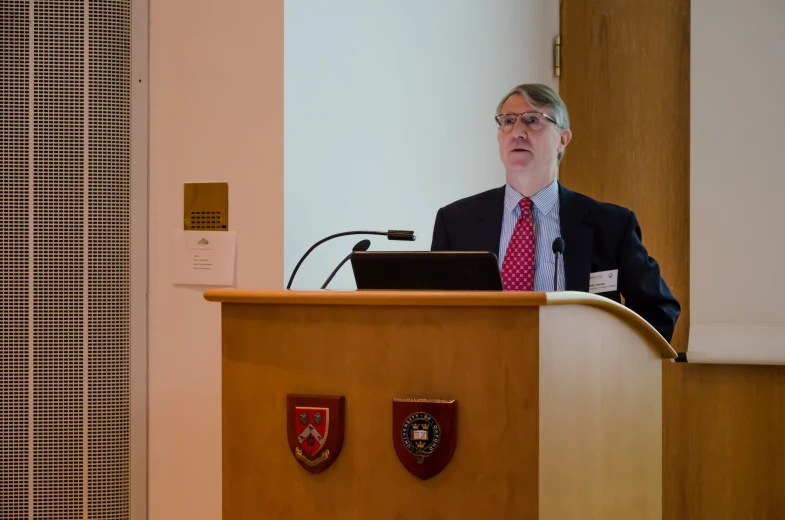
[539,305,669,520]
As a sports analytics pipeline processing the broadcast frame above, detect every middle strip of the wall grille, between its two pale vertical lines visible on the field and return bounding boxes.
[33,0,85,520]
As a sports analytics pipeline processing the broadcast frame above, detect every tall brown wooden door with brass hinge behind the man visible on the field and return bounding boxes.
[559,0,690,351]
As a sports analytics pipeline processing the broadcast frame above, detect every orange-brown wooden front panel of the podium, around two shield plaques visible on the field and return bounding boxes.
[222,303,539,520]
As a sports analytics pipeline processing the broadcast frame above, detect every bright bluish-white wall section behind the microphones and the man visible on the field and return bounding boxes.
[284,0,559,289]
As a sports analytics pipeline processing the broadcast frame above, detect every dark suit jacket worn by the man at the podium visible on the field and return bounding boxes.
[431,184,681,341]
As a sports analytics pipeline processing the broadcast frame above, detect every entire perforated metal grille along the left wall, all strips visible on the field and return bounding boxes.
[0,0,131,520]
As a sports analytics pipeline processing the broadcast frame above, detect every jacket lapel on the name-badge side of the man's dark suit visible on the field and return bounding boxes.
[559,183,594,292]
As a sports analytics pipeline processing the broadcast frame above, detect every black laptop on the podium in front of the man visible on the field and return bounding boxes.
[351,251,503,291]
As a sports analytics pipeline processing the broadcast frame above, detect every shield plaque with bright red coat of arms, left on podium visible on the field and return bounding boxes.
[286,394,345,473]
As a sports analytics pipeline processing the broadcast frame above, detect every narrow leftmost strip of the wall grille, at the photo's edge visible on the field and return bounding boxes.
[0,0,30,520]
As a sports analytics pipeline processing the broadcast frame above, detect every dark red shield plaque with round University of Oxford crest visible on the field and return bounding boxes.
[393,399,458,480]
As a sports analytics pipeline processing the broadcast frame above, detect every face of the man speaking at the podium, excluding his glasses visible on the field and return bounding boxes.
[498,94,572,179]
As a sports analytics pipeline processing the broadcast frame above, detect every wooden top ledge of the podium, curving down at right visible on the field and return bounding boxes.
[204,289,676,359]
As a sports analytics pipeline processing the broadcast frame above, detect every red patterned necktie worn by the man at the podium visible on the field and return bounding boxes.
[501,198,534,291]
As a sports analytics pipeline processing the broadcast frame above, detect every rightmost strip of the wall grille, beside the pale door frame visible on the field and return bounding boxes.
[88,0,131,520]
